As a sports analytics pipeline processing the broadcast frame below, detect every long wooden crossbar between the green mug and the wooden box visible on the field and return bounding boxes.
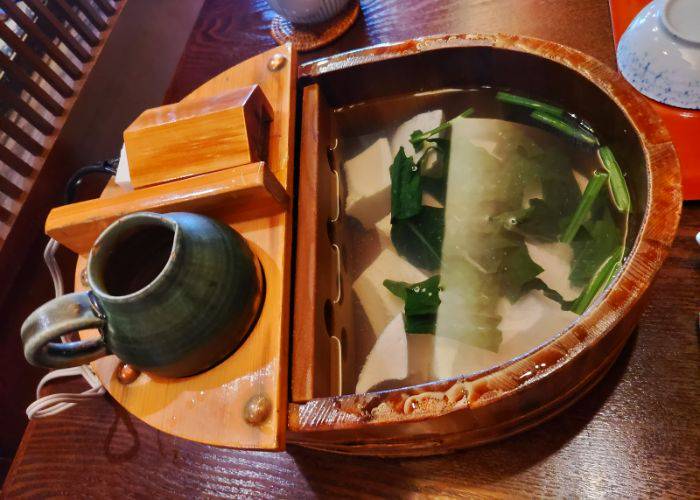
[45,162,289,254]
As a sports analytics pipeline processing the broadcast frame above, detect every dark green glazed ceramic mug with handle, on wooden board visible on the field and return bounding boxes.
[22,212,264,377]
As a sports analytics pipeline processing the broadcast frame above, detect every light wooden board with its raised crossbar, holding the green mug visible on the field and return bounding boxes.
[71,45,296,450]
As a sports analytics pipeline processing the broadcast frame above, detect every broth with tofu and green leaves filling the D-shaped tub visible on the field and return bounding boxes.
[336,87,630,392]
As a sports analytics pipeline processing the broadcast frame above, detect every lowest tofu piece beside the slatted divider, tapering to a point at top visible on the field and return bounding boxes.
[355,313,408,394]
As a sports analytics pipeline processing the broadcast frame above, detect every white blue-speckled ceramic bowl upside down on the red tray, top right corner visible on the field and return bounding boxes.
[617,0,700,109]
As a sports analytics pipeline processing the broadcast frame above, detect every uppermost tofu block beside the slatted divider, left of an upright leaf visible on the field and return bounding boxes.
[343,138,393,229]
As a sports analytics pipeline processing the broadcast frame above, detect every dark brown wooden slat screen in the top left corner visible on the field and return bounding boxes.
[0,0,125,300]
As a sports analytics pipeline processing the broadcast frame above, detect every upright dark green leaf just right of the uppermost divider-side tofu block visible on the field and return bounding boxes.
[389,147,423,221]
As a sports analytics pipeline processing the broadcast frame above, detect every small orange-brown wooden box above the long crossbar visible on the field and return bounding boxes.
[124,85,273,188]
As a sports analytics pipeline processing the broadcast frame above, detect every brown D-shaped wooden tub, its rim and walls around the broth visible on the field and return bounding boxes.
[287,35,682,456]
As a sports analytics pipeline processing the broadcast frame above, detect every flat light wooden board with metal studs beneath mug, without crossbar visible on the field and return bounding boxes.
[75,45,297,450]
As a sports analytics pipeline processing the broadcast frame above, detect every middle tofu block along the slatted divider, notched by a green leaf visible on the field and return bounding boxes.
[352,248,428,335]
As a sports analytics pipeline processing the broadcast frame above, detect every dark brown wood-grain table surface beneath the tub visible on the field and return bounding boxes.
[4,0,700,498]
